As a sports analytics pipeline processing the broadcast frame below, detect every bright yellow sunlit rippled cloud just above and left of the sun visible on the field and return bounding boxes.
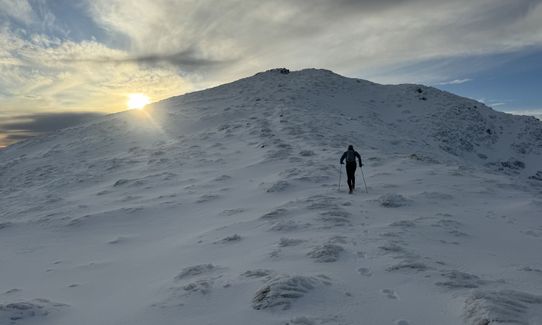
[0,28,198,115]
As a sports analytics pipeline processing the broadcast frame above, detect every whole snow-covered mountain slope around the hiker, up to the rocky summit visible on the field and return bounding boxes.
[0,69,542,325]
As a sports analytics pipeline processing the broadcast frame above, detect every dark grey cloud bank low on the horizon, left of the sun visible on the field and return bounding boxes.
[0,112,103,147]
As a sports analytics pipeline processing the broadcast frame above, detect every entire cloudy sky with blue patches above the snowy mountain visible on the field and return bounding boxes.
[0,0,542,147]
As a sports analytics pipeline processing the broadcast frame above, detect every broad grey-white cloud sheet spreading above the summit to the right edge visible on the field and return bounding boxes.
[84,0,542,80]
